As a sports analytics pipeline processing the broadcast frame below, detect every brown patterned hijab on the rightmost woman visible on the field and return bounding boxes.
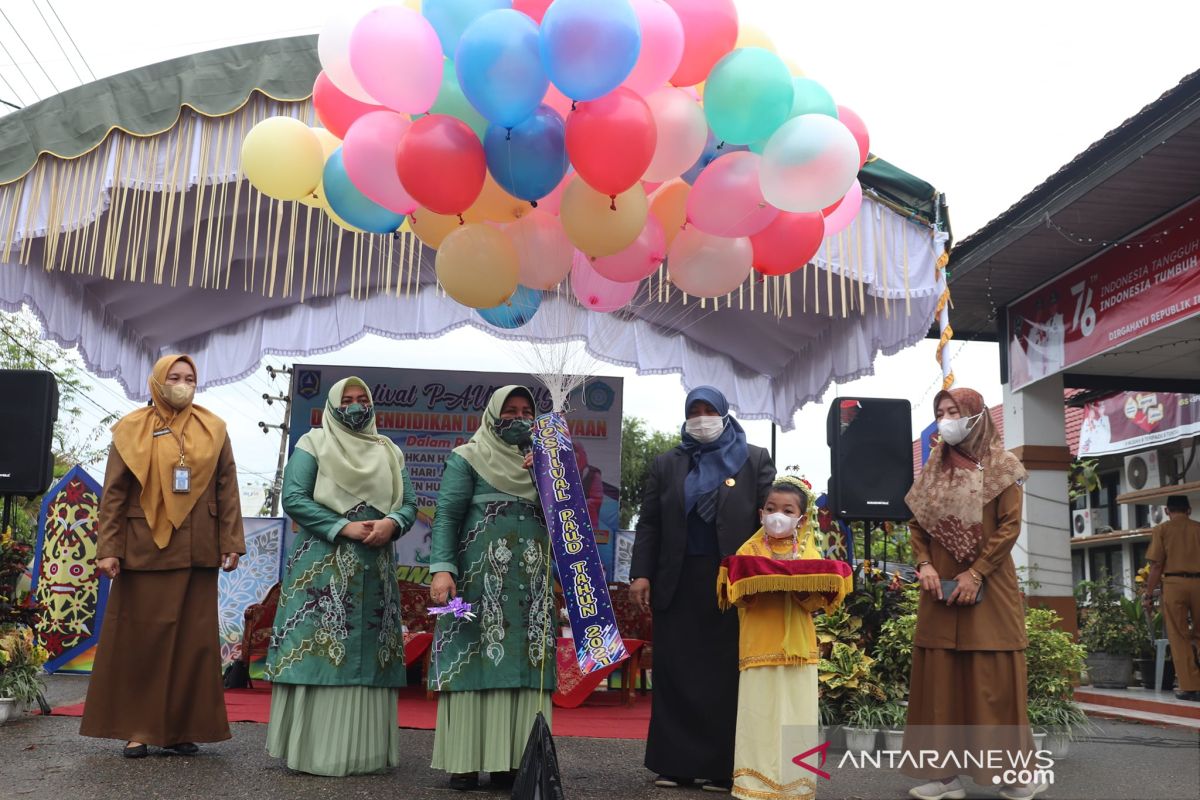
[905,389,1025,564]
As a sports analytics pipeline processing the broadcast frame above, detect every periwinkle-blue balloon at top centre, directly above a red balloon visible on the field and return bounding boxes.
[541,0,642,102]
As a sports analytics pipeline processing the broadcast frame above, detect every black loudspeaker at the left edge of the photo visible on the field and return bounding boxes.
[0,369,59,497]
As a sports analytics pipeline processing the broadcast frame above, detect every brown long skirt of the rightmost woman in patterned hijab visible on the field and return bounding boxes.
[900,646,1038,786]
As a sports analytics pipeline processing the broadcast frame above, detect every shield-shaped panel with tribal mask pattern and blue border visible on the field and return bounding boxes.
[31,465,109,673]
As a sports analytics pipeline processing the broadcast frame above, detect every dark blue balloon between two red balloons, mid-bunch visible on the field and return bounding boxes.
[484,106,570,200]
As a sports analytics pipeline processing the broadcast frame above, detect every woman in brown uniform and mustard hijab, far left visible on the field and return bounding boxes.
[79,355,246,758]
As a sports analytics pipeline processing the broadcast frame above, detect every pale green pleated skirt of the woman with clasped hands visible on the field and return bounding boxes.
[266,684,400,777]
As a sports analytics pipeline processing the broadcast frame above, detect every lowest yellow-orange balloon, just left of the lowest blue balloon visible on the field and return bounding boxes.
[433,222,517,308]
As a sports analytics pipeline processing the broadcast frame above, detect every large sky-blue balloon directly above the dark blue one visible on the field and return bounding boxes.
[455,8,550,128]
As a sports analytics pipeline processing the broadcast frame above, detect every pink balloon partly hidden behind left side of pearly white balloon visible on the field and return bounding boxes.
[688,150,779,236]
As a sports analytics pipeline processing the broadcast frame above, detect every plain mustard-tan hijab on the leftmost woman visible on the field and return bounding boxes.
[113,354,227,549]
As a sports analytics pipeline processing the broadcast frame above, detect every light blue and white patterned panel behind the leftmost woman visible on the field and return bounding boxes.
[217,517,287,676]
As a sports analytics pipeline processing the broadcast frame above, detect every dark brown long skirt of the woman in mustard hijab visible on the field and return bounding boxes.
[79,569,232,747]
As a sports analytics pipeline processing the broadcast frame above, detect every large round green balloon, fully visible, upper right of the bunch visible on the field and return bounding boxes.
[704,47,796,144]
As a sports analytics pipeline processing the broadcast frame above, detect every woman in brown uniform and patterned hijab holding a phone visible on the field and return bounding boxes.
[901,389,1045,800]
